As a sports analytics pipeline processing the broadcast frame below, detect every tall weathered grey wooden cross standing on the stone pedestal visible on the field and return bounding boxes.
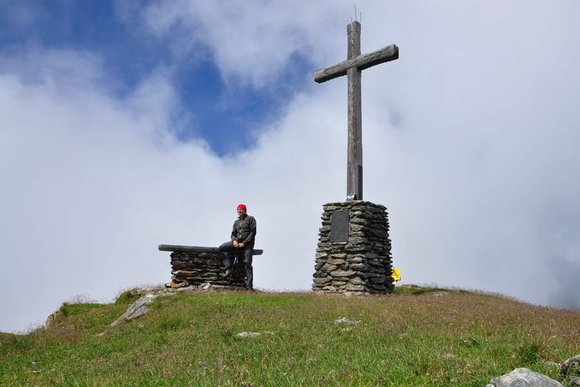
[314,21,399,200]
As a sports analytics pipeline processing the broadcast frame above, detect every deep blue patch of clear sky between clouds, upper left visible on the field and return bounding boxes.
[0,0,313,156]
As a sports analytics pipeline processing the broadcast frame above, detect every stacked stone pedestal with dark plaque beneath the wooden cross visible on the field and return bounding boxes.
[312,201,394,293]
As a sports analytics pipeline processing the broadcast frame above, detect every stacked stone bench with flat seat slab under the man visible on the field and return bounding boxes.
[159,245,264,288]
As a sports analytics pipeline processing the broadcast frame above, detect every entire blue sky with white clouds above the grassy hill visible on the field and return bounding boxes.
[0,0,580,332]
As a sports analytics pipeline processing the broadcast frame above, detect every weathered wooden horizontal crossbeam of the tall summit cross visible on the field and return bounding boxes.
[314,44,399,83]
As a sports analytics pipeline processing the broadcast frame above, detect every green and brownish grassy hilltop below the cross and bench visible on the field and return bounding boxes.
[0,288,580,386]
